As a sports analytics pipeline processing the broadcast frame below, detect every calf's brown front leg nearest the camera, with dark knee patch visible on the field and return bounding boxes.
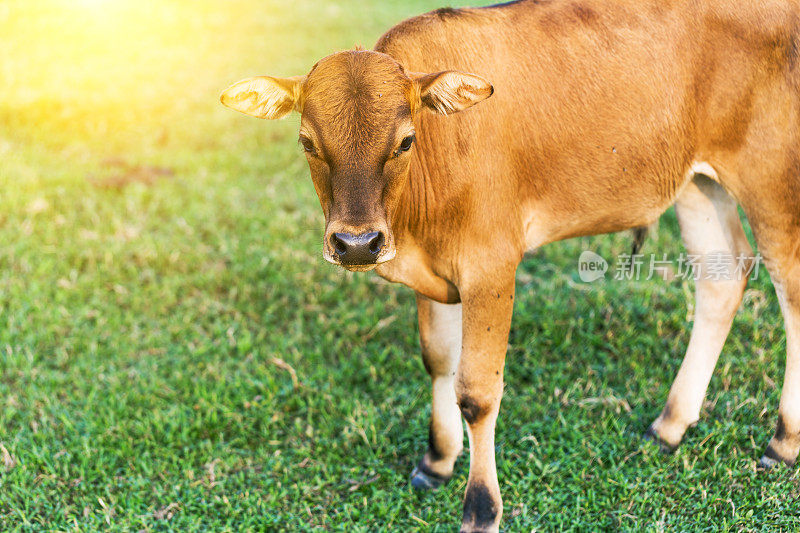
[455,269,514,532]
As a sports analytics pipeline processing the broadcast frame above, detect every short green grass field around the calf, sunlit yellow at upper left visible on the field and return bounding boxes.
[0,0,800,532]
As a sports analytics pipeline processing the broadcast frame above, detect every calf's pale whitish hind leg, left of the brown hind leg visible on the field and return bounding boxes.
[646,174,752,450]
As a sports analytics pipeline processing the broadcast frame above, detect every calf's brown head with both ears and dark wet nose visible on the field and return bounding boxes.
[221,50,493,270]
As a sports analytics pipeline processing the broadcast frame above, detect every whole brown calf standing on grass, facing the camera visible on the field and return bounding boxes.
[222,0,800,531]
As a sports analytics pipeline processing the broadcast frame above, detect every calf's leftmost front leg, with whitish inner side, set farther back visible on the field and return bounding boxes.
[411,294,464,490]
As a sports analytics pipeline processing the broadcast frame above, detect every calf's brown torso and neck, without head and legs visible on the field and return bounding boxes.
[376,0,798,302]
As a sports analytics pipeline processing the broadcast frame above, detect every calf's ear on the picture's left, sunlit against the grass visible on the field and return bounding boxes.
[220,76,305,119]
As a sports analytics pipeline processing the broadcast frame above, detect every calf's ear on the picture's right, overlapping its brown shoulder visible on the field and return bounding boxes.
[411,70,494,115]
